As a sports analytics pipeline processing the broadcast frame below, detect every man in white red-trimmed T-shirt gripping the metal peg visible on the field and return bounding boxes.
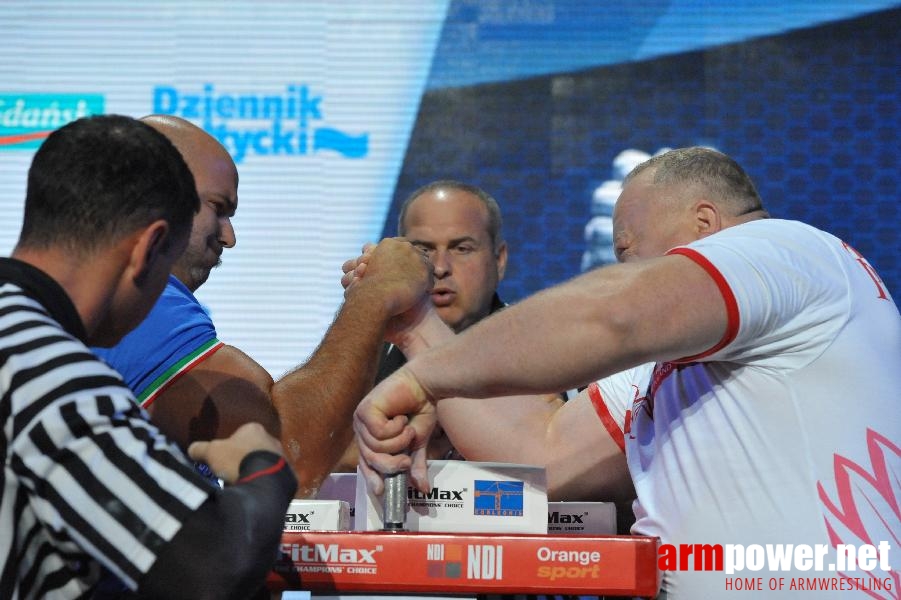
[355,148,901,598]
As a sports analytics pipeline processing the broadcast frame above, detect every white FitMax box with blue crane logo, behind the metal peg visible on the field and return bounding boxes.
[354,460,548,534]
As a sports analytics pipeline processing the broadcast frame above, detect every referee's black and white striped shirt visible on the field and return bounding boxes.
[0,259,212,598]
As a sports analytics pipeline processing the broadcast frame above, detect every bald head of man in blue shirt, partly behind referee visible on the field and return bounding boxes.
[141,115,238,291]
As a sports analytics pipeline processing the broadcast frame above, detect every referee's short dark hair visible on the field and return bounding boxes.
[18,115,200,256]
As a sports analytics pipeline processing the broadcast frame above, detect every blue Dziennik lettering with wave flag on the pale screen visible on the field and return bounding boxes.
[153,83,369,163]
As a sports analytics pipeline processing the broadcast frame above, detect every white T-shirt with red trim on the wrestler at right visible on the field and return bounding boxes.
[625,219,901,600]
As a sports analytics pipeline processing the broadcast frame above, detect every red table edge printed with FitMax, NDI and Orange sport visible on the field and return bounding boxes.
[267,531,659,598]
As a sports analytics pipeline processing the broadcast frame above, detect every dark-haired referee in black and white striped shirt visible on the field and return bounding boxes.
[0,115,297,599]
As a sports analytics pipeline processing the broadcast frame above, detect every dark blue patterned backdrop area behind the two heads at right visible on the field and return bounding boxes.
[385,2,901,301]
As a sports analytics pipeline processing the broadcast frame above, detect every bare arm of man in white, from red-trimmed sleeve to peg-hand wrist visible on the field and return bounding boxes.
[406,256,726,398]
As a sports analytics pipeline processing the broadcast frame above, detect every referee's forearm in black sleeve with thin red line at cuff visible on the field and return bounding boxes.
[138,451,297,600]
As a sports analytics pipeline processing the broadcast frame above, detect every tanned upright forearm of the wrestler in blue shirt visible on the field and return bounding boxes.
[272,284,389,497]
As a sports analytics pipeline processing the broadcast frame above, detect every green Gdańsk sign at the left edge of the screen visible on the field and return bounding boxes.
[0,94,103,150]
